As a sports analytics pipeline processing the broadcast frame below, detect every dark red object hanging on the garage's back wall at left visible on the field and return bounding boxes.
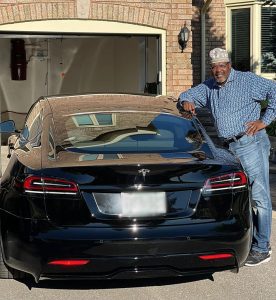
[11,39,27,80]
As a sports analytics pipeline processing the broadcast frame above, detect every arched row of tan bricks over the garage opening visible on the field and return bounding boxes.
[0,0,170,29]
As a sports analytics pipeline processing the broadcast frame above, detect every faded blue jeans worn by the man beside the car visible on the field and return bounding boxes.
[229,129,272,252]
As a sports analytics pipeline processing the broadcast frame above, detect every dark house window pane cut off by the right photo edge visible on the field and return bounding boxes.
[261,7,276,73]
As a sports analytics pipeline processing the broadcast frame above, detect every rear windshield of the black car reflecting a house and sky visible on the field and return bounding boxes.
[56,111,203,154]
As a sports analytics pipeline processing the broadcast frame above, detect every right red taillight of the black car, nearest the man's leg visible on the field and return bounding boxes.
[204,172,247,191]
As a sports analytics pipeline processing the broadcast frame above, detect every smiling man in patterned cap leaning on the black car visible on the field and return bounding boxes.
[178,48,276,266]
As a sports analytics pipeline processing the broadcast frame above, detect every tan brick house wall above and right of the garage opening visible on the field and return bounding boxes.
[0,0,225,97]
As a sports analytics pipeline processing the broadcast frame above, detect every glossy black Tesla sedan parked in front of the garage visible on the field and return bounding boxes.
[0,94,252,282]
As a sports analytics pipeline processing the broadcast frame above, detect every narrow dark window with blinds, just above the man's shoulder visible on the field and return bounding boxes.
[231,8,250,71]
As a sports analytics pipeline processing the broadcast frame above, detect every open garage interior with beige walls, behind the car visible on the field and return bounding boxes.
[0,34,162,130]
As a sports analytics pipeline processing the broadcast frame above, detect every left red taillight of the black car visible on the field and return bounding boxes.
[23,176,78,194]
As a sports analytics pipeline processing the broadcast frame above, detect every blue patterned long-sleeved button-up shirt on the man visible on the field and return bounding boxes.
[179,69,276,138]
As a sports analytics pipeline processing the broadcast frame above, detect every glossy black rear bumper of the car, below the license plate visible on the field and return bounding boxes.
[3,218,251,281]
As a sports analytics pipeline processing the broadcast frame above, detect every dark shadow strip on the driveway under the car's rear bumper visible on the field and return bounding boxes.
[17,275,214,290]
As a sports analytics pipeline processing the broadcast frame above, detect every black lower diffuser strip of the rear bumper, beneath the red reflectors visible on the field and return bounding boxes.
[40,254,238,280]
